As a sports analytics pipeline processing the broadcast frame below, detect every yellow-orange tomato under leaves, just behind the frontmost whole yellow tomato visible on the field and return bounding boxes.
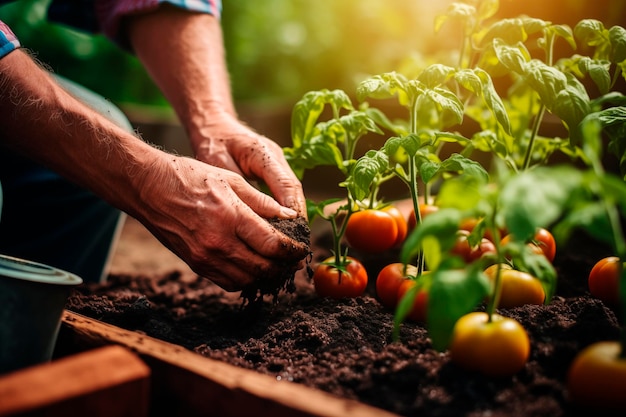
[485,264,546,308]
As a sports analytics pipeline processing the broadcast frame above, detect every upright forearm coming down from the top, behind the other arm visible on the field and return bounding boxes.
[127,6,236,149]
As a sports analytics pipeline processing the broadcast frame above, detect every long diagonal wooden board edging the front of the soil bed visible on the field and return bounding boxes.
[59,311,397,417]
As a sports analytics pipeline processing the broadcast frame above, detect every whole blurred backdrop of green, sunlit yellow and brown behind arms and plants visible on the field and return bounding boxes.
[0,0,626,195]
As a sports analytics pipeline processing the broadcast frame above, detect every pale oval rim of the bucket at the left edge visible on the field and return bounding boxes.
[0,255,83,285]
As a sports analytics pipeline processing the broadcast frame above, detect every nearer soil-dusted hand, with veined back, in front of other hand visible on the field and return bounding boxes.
[135,155,308,291]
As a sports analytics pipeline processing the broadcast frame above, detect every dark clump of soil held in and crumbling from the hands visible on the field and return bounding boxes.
[241,217,311,305]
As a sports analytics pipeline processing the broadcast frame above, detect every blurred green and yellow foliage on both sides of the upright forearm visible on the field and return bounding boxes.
[0,0,454,111]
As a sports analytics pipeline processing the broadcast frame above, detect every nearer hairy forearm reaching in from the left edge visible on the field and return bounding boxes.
[0,50,157,212]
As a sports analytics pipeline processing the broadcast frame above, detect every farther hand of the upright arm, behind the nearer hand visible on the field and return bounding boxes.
[192,113,306,217]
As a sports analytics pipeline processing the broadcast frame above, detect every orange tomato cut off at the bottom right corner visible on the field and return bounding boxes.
[567,341,626,415]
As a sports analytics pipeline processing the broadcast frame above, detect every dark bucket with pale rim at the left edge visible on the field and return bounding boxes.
[0,255,83,374]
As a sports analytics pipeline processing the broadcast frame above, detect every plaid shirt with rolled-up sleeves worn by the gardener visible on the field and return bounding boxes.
[0,0,222,58]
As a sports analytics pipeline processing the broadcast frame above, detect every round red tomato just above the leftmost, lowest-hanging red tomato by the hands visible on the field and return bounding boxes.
[346,209,398,253]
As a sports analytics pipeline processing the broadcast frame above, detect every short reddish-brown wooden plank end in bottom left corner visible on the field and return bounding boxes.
[0,346,150,417]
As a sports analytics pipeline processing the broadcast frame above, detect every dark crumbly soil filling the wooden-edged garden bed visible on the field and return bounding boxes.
[67,214,620,417]
